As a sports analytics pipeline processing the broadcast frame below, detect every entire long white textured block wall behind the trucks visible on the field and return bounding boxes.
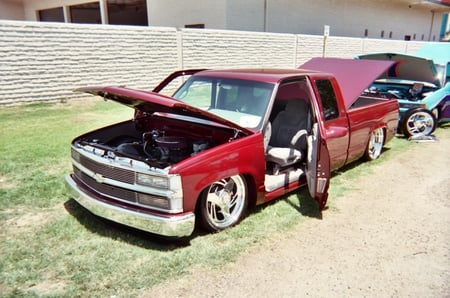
[0,21,423,105]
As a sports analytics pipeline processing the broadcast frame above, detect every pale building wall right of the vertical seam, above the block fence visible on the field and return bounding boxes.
[267,0,442,40]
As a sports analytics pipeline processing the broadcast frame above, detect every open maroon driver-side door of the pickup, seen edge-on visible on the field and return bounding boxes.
[306,123,331,210]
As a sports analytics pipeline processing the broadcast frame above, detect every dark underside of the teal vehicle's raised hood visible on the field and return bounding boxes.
[356,53,440,87]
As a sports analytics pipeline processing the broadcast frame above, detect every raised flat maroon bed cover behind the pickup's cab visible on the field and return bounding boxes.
[299,58,394,108]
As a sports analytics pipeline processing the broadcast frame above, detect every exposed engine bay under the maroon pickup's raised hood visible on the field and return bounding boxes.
[74,115,234,168]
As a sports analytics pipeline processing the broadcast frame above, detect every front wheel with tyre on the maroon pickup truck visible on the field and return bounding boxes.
[198,175,248,232]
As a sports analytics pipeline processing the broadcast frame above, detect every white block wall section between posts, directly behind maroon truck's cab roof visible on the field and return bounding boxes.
[181,29,296,68]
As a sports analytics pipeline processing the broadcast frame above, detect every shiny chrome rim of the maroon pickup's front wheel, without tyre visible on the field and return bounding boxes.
[205,175,247,229]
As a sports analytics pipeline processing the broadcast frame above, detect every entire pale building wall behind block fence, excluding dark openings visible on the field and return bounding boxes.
[0,0,450,41]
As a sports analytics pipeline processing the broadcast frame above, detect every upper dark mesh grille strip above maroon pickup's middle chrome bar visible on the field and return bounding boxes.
[72,149,135,184]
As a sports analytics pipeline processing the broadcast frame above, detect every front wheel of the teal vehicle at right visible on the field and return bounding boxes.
[402,109,436,137]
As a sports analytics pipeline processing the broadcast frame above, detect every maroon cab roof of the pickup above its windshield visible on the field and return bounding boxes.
[195,68,317,83]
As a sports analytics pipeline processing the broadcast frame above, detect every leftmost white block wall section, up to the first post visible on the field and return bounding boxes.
[0,22,178,104]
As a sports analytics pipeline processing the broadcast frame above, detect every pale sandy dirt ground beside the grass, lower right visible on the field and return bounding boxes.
[146,127,450,297]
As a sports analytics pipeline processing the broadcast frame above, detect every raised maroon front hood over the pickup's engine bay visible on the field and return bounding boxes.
[75,86,252,133]
